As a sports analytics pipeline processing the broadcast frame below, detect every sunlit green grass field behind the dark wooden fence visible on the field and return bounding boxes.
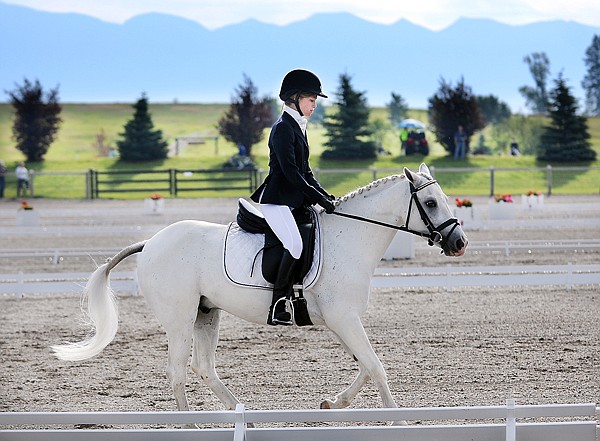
[0,104,600,198]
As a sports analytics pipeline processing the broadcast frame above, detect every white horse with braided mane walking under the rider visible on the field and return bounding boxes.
[53,164,467,410]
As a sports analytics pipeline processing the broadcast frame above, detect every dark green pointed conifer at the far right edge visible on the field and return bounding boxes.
[538,76,596,162]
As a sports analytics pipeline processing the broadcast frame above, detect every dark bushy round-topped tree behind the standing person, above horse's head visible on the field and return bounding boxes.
[428,78,485,154]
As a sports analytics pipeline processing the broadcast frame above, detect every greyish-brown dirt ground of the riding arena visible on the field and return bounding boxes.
[0,196,600,411]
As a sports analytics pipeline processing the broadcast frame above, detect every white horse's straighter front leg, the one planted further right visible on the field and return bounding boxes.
[327,315,406,424]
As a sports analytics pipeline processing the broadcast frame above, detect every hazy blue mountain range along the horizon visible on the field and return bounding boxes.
[0,2,600,112]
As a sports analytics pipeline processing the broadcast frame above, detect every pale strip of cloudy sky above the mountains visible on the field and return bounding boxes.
[2,0,600,30]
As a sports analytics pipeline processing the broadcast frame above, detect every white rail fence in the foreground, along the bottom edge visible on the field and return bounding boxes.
[0,399,600,441]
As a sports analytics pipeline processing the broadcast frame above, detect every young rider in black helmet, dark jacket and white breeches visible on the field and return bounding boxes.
[251,69,335,326]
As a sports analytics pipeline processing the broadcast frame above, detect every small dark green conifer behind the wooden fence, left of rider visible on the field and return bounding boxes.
[117,93,168,161]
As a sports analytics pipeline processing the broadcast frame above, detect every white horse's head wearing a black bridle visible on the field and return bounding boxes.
[404,163,468,257]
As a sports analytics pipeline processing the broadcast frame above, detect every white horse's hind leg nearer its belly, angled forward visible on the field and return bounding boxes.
[192,309,239,410]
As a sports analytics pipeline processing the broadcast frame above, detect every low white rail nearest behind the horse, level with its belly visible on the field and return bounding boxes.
[0,264,600,299]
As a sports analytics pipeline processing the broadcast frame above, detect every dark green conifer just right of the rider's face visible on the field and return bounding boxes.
[321,74,377,159]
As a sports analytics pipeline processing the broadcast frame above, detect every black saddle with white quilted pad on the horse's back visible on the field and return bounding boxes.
[224,199,321,326]
